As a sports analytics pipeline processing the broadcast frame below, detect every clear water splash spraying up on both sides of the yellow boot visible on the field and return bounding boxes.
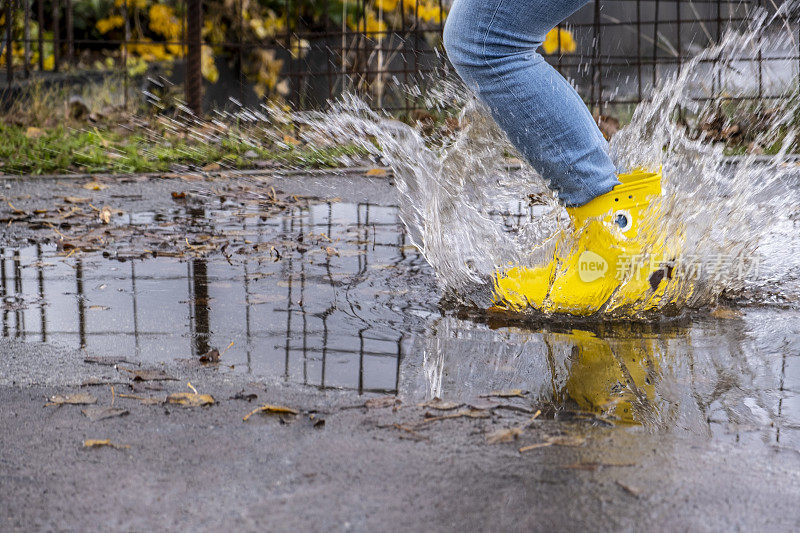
[293,2,800,314]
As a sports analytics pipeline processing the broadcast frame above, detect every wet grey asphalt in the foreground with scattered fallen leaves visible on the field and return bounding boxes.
[0,172,800,531]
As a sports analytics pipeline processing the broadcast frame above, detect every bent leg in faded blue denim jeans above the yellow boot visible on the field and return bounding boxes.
[444,0,619,207]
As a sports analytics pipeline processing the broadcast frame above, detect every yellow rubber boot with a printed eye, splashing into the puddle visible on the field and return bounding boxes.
[495,171,669,315]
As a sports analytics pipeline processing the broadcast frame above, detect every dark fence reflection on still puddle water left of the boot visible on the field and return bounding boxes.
[0,202,424,392]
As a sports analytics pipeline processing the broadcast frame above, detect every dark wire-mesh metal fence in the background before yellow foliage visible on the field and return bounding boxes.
[0,0,800,112]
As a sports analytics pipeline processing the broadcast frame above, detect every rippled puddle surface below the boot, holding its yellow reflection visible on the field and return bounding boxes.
[401,309,800,444]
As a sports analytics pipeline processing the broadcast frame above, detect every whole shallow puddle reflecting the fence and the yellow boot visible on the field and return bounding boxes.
[0,177,800,448]
